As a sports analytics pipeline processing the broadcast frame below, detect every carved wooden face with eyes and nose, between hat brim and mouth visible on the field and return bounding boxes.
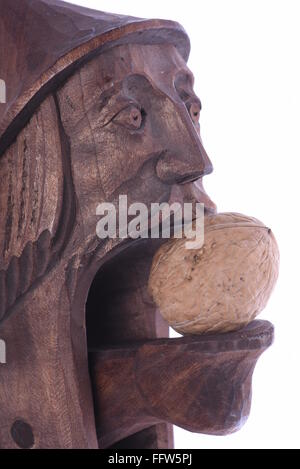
[58,44,214,241]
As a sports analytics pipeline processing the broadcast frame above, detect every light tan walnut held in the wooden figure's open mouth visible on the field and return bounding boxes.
[148,213,279,334]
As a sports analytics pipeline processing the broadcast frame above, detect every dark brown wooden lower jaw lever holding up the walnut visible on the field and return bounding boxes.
[90,321,273,448]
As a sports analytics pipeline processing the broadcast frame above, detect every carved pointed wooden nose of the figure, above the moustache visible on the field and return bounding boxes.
[156,107,213,184]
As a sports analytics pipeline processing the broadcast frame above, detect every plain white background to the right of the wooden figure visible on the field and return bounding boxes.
[73,0,300,448]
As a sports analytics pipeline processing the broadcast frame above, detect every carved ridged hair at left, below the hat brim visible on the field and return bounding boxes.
[0,95,75,320]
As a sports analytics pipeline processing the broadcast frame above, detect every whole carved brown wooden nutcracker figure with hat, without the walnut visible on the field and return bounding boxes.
[0,0,273,448]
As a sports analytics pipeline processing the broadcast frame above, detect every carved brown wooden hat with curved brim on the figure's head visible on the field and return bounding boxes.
[0,0,190,155]
